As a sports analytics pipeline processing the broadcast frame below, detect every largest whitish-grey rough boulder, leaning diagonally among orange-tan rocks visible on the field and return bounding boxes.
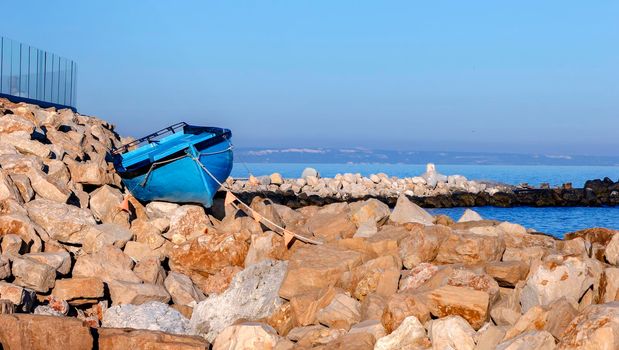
[191,260,288,341]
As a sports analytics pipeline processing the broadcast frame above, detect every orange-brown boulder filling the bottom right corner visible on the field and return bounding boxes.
[559,301,619,350]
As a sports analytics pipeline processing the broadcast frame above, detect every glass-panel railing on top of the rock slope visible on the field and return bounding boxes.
[0,36,77,109]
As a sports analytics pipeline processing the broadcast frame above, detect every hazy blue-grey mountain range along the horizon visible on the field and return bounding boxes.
[235,147,619,166]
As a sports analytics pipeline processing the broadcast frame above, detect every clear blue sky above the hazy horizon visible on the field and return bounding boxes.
[0,0,619,155]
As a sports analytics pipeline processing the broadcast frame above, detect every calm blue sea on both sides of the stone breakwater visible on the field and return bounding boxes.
[232,163,619,237]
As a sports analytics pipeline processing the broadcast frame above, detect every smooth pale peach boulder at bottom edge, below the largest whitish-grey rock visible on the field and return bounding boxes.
[213,322,279,350]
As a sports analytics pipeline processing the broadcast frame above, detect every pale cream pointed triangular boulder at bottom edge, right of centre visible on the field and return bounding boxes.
[374,316,430,350]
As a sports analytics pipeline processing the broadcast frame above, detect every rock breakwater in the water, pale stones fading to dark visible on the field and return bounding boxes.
[228,164,619,208]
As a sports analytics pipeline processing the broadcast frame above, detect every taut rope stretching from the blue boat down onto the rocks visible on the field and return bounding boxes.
[187,153,322,246]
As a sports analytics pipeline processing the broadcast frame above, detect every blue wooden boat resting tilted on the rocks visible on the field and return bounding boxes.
[112,122,232,207]
